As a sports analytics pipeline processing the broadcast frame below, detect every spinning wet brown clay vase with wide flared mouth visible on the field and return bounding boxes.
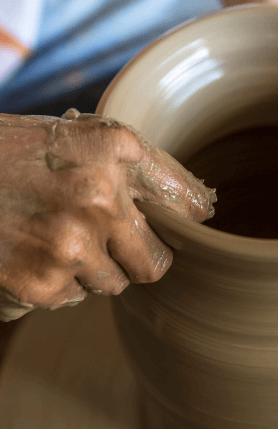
[97,5,278,429]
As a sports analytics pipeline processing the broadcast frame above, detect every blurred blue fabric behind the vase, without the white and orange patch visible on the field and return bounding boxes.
[0,0,220,112]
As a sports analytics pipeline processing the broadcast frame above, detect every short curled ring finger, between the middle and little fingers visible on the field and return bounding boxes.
[75,248,130,295]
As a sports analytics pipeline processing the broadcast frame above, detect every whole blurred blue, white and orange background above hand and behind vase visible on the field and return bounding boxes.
[0,0,221,116]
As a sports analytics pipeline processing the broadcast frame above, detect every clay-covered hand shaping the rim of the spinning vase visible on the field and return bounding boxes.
[0,109,216,321]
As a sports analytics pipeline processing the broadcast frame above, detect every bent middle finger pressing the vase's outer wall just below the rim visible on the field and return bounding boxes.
[108,203,173,283]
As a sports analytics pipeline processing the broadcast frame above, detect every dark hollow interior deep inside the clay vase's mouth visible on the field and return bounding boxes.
[184,127,278,239]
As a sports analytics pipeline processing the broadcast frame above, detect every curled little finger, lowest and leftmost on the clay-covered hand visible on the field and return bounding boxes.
[1,239,87,309]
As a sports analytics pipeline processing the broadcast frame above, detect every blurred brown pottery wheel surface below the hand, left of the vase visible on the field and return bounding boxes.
[0,296,137,429]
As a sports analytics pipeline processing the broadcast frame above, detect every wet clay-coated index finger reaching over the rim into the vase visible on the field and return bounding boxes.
[129,148,217,222]
